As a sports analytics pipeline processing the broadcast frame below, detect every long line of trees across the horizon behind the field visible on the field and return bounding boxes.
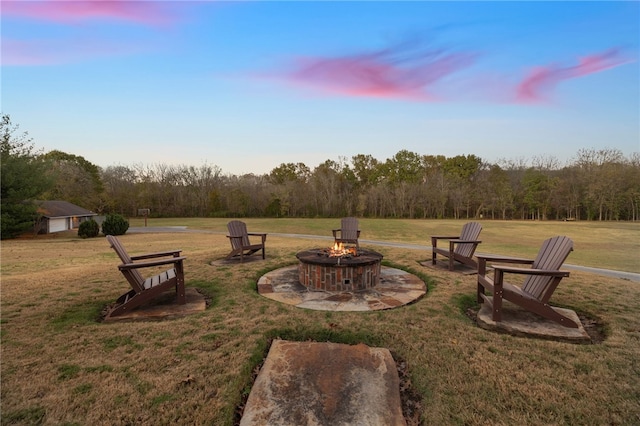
[0,115,640,238]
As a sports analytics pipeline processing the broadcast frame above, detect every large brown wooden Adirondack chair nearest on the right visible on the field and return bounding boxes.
[477,236,579,328]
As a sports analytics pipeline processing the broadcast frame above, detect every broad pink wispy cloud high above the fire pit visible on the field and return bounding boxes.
[284,43,474,101]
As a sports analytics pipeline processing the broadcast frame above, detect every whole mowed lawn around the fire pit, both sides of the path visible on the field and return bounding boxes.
[0,219,640,425]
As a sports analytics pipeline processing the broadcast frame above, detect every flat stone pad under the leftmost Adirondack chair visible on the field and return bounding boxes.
[104,287,207,322]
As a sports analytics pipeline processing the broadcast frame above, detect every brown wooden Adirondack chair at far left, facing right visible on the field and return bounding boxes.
[107,235,186,317]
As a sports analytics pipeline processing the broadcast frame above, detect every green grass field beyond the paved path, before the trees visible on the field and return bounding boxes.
[130,218,640,273]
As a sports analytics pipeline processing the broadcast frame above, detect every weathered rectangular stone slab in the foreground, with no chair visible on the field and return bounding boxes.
[240,340,407,426]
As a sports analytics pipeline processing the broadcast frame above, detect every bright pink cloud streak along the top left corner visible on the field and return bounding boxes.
[2,0,175,25]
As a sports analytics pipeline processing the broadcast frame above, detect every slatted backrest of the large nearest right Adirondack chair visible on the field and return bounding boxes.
[522,236,573,303]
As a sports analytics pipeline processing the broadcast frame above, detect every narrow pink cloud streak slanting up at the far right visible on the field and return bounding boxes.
[516,49,629,103]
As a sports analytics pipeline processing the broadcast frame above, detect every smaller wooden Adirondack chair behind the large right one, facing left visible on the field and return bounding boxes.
[431,222,482,271]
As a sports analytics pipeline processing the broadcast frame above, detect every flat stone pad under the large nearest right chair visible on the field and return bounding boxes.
[477,301,591,343]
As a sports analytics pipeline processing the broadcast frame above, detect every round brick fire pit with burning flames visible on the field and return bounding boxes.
[296,245,382,292]
